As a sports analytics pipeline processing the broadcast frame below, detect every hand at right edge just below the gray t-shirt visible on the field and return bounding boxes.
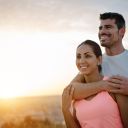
[108,75,128,95]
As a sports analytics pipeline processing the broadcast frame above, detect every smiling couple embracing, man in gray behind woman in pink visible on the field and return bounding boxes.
[62,12,128,128]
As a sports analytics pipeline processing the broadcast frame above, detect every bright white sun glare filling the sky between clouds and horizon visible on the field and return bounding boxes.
[0,31,99,99]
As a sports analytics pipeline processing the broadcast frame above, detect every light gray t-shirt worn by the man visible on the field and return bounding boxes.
[102,50,128,77]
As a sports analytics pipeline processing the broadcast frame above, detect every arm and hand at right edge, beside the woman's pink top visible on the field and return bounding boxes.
[109,75,128,128]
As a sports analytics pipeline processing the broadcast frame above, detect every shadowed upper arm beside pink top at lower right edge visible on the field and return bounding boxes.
[116,94,128,128]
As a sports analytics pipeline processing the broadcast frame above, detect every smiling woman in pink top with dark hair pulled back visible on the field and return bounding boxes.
[62,40,123,128]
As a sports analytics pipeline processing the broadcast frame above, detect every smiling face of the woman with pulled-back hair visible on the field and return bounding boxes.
[76,44,100,75]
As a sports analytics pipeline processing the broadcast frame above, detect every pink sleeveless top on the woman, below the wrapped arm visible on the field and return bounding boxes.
[74,91,123,128]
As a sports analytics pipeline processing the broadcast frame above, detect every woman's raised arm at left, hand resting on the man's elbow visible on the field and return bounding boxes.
[62,87,80,128]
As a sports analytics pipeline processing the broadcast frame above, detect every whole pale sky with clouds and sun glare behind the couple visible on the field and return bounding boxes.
[0,0,128,98]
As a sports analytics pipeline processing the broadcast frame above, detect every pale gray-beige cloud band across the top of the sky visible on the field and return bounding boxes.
[0,0,128,31]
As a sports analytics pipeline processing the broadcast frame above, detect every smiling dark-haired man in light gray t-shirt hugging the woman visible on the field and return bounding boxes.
[69,12,128,128]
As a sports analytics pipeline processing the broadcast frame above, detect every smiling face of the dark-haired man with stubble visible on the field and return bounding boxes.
[98,19,120,48]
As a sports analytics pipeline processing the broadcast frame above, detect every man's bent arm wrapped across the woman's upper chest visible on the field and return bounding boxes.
[69,74,113,100]
